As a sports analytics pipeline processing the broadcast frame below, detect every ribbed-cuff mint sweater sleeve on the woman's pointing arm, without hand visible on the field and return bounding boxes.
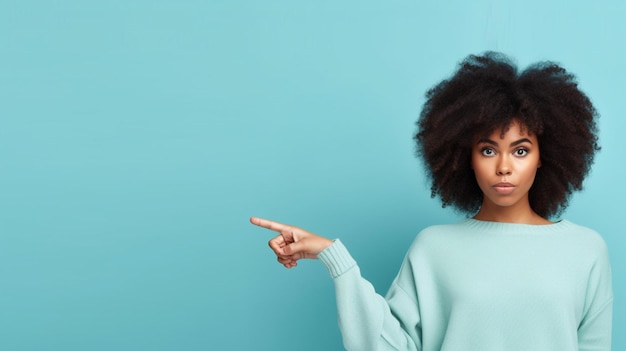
[318,240,421,351]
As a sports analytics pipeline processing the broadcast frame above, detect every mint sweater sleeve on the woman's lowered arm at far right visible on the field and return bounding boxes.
[578,242,613,351]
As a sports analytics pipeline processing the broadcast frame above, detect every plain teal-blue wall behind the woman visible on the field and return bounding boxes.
[0,0,626,350]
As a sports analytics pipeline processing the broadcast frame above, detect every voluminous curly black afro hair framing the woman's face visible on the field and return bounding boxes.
[415,52,600,218]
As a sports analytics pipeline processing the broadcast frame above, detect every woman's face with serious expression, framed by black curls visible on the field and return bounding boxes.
[472,121,541,211]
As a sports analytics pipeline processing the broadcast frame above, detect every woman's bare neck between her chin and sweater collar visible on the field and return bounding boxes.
[474,201,552,224]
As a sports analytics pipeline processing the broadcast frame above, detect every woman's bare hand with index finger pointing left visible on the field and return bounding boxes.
[250,217,333,268]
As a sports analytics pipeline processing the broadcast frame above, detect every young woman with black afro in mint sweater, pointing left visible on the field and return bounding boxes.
[251,53,613,351]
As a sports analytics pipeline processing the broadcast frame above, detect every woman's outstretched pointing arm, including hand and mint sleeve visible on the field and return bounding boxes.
[250,217,421,351]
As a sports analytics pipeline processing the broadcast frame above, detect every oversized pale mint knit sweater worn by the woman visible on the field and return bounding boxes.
[318,219,613,351]
